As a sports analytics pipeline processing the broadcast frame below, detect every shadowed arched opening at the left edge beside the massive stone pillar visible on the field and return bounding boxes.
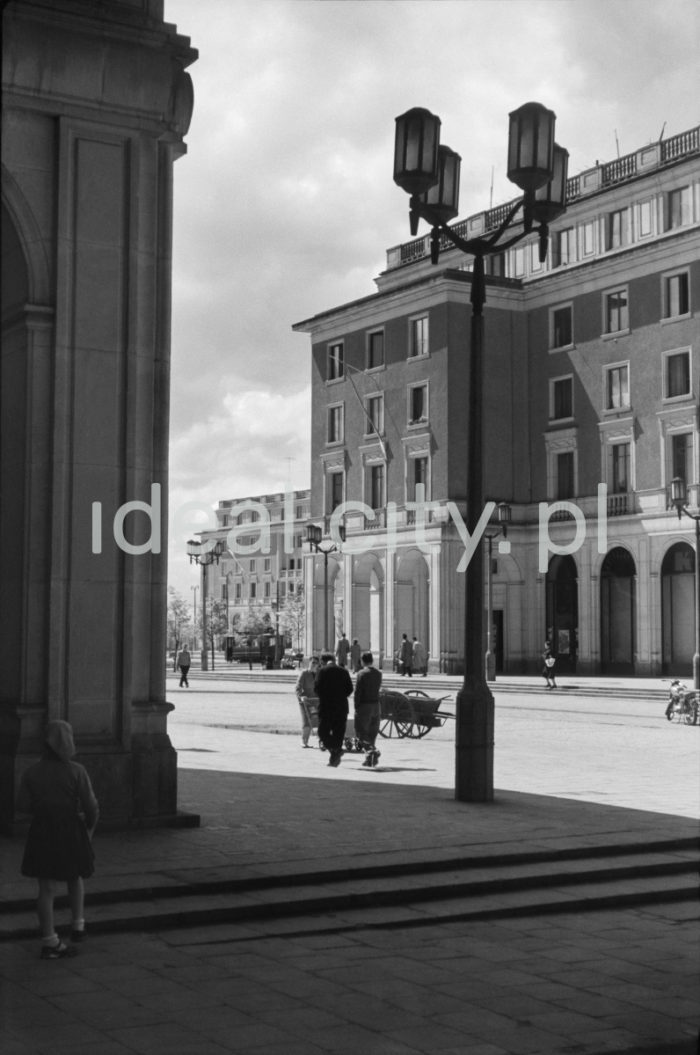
[0,205,30,702]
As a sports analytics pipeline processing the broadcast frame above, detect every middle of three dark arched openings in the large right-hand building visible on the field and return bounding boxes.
[600,546,637,674]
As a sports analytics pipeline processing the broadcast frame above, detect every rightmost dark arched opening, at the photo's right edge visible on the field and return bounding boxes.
[661,542,695,677]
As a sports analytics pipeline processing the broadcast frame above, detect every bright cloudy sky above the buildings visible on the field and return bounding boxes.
[166,0,700,595]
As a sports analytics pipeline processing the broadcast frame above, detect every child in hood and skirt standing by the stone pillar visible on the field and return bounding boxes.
[20,721,99,960]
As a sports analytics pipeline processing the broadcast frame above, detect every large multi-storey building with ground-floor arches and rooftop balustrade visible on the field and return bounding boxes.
[294,128,700,674]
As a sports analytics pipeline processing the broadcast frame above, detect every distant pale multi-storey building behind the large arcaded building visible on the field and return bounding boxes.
[201,490,310,631]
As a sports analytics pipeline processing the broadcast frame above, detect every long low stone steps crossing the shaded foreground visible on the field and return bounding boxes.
[0,849,698,940]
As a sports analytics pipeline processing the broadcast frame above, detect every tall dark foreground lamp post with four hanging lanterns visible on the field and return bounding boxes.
[393,102,568,802]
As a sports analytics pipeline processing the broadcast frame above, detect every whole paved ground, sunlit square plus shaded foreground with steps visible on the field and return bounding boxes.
[0,664,700,1055]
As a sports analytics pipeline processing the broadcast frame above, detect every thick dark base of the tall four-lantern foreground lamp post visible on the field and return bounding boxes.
[454,677,495,802]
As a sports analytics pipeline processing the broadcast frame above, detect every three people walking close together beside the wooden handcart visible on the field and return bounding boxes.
[295,634,382,768]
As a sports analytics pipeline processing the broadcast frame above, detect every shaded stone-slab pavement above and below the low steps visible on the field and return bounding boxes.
[0,675,700,1055]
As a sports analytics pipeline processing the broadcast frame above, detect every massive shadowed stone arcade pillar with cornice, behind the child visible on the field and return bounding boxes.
[0,0,197,830]
